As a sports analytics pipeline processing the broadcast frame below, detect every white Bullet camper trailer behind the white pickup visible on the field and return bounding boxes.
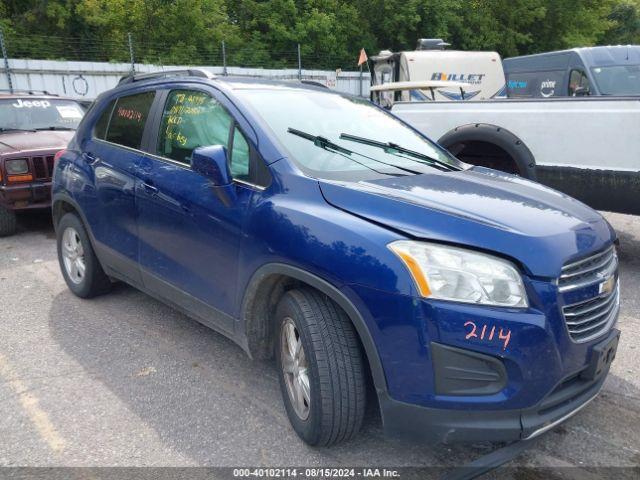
[371,39,505,106]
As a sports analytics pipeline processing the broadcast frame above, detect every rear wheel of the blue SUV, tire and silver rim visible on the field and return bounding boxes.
[56,213,111,298]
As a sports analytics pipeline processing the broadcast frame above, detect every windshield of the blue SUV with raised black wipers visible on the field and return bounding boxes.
[232,89,462,181]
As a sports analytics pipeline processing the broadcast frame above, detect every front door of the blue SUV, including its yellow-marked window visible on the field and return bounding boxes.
[137,90,259,333]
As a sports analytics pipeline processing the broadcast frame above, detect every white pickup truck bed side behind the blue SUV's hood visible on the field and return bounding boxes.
[391,97,640,215]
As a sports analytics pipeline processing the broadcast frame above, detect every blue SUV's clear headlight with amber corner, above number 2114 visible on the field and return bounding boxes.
[389,240,528,308]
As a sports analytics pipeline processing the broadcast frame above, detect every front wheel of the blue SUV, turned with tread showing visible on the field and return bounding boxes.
[274,288,366,446]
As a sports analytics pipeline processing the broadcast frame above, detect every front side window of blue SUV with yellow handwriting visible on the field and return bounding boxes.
[158,90,233,165]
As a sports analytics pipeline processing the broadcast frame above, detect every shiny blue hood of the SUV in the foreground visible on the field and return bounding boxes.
[320,167,615,277]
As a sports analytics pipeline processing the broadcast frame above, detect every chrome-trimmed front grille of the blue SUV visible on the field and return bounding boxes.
[558,246,620,342]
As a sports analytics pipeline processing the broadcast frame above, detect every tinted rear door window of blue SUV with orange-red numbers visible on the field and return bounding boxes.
[106,92,155,148]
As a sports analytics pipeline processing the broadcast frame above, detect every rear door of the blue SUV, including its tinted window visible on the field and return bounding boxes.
[83,90,156,285]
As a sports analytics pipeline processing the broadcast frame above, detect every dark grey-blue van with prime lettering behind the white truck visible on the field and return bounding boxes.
[503,45,640,98]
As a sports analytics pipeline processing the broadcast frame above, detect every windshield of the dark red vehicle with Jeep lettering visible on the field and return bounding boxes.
[0,97,83,131]
